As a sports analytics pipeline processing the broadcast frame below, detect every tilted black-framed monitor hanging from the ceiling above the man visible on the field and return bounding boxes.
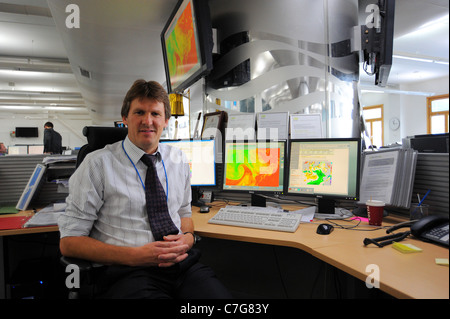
[161,0,213,93]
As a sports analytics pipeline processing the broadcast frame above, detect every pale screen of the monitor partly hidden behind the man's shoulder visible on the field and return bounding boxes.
[161,140,216,186]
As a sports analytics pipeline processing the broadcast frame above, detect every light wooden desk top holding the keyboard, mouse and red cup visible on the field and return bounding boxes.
[192,207,449,299]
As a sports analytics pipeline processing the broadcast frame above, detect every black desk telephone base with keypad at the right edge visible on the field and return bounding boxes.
[411,215,449,247]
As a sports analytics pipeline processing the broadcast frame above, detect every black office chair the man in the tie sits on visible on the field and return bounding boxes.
[60,126,128,299]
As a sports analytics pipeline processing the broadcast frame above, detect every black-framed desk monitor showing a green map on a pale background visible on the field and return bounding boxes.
[286,138,361,216]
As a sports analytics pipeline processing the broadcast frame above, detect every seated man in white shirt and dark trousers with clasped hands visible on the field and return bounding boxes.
[58,80,230,298]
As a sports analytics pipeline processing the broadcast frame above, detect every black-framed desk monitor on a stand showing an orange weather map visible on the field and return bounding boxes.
[223,141,286,206]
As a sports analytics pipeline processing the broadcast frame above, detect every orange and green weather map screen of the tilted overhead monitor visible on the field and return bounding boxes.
[165,1,201,87]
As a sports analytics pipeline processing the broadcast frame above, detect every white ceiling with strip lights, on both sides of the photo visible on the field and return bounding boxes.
[0,0,449,124]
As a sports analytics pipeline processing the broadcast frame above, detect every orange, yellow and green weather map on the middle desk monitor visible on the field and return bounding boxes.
[225,148,280,187]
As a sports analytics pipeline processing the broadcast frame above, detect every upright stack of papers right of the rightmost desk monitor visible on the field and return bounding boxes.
[360,149,418,208]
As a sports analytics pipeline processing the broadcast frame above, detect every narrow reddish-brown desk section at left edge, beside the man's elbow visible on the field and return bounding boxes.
[0,211,58,299]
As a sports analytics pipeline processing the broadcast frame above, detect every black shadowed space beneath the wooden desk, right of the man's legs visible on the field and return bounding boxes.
[198,238,392,299]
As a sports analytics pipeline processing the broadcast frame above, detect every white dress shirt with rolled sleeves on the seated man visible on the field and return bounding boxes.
[58,137,191,247]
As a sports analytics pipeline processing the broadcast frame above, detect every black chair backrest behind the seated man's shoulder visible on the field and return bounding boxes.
[76,126,128,167]
